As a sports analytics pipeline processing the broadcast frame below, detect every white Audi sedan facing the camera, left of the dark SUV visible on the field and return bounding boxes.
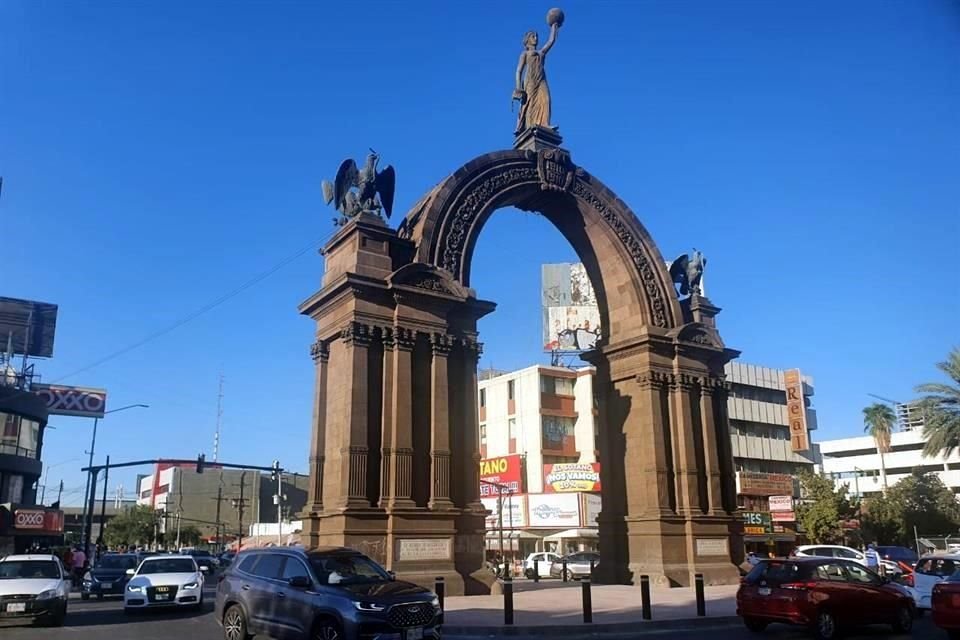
[123,555,204,613]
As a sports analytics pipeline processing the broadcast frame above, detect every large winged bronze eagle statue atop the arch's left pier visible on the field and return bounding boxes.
[323,149,397,226]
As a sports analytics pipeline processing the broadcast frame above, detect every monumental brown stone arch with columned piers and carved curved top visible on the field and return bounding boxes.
[300,13,743,595]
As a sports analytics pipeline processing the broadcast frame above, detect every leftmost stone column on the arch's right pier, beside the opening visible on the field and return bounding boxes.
[626,371,675,516]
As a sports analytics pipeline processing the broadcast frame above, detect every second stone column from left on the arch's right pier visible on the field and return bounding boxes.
[670,373,702,516]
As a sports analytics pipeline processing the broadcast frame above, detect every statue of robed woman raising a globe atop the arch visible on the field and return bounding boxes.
[513,9,563,134]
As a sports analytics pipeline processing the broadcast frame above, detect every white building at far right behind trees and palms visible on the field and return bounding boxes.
[820,429,960,497]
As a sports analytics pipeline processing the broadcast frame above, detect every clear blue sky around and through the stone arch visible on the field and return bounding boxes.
[0,0,960,501]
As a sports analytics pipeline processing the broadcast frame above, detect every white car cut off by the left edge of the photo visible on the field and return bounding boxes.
[0,554,70,627]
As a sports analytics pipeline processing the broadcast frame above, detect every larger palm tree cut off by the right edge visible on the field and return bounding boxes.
[917,347,960,457]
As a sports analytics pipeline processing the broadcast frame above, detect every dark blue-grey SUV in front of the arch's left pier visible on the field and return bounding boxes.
[215,547,443,640]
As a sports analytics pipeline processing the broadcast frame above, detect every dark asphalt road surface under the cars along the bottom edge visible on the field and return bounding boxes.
[0,590,946,640]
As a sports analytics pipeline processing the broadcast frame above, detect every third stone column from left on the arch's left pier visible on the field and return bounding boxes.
[384,326,416,509]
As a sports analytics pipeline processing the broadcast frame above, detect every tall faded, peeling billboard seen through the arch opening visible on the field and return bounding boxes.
[540,262,600,352]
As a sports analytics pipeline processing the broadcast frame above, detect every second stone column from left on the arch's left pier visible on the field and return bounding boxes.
[337,321,373,508]
